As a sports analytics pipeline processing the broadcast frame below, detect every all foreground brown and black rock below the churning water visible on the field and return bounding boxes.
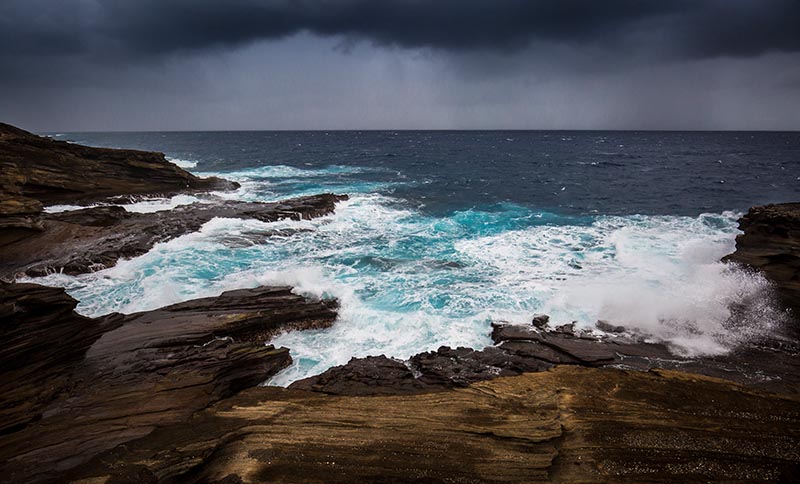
[0,284,800,483]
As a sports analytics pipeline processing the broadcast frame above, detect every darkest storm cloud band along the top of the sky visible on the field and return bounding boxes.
[0,0,800,59]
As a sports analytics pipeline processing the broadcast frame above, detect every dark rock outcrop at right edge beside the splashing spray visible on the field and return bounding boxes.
[725,203,800,339]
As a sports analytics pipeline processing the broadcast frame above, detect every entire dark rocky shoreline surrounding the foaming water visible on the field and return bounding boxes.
[0,125,800,484]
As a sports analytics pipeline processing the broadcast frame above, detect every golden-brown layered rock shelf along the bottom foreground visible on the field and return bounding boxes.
[63,366,800,484]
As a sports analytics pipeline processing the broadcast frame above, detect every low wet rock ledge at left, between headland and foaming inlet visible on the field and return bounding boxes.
[0,194,347,279]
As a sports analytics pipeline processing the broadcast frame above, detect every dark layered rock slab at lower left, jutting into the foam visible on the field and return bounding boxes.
[0,283,336,482]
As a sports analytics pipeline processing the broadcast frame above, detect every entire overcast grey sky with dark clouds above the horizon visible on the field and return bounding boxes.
[0,0,800,131]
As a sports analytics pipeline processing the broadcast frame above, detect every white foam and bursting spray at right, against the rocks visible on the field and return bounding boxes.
[458,213,783,355]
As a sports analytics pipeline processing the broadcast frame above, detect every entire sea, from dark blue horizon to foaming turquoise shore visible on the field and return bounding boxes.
[38,131,800,384]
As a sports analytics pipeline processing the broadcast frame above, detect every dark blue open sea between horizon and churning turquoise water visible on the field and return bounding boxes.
[53,131,800,215]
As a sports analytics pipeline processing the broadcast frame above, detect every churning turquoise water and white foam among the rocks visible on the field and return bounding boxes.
[31,131,782,384]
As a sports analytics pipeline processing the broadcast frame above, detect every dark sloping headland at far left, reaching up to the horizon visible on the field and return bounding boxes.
[0,123,237,233]
